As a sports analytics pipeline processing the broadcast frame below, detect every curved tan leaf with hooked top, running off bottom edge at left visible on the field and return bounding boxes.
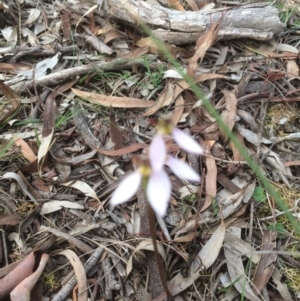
[59,250,88,301]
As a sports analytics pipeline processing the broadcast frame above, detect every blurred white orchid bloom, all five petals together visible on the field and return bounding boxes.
[110,129,202,217]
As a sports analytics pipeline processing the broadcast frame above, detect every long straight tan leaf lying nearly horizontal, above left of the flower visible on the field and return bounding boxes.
[72,89,155,108]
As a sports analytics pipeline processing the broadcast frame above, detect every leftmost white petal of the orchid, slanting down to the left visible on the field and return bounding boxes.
[110,171,142,206]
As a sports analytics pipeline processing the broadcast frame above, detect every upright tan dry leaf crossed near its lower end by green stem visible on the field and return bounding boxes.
[220,90,238,143]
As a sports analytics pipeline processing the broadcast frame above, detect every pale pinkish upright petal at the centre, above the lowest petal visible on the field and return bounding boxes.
[149,135,166,172]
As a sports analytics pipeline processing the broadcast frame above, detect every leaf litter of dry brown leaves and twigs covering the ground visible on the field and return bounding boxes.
[0,0,300,300]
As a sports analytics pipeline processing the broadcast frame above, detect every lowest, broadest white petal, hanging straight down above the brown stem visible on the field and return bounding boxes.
[147,170,171,217]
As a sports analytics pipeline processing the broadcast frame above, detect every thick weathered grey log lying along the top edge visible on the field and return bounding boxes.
[99,0,284,45]
